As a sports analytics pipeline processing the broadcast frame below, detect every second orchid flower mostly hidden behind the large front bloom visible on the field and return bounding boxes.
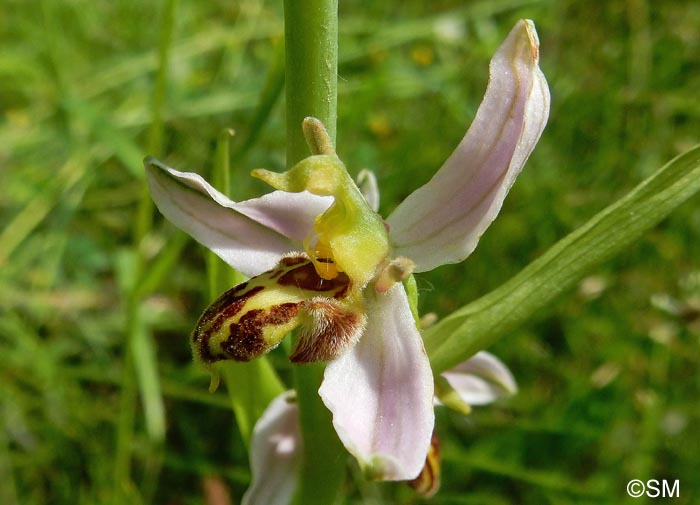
[242,351,517,505]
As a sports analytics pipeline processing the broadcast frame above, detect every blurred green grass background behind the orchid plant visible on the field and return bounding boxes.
[0,0,700,505]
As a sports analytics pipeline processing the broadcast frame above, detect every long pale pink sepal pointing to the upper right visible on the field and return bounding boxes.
[387,20,549,272]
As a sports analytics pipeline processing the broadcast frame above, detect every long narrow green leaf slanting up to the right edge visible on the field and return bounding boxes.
[424,146,700,373]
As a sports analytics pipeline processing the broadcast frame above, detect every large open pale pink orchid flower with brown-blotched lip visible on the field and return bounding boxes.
[145,20,549,480]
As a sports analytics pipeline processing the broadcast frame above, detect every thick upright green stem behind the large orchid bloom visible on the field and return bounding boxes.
[284,0,345,505]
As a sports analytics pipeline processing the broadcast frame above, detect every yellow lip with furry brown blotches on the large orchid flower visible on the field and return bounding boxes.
[192,256,356,363]
